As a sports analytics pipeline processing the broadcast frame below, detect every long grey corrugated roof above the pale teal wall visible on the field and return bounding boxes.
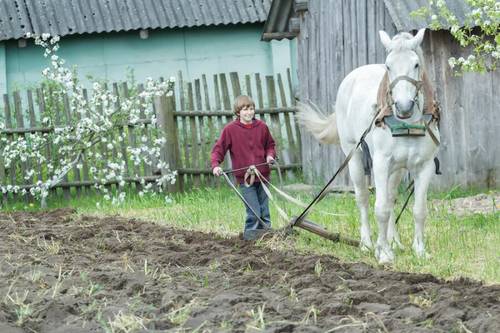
[0,0,271,40]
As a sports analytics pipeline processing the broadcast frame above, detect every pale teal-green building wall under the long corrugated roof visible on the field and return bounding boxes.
[0,24,295,97]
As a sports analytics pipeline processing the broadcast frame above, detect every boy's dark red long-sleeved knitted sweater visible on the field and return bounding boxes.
[211,119,276,184]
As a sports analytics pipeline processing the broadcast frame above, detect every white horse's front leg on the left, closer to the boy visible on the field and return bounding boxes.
[373,153,394,264]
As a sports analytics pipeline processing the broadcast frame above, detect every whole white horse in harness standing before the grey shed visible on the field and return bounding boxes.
[298,29,439,264]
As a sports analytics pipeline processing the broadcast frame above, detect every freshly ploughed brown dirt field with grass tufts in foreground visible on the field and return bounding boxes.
[0,210,500,333]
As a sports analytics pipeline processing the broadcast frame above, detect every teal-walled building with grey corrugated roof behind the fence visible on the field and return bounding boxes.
[0,0,294,94]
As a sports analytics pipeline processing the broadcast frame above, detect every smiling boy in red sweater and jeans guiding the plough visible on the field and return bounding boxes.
[211,96,276,240]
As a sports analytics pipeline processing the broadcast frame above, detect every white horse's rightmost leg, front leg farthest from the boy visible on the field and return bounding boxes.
[413,160,434,258]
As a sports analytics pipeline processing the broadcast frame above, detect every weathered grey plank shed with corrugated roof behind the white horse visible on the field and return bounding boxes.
[263,0,500,189]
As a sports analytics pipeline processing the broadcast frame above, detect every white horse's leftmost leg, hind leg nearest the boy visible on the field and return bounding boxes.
[349,150,373,251]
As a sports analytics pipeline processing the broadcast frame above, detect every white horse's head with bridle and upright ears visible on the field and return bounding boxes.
[379,29,425,120]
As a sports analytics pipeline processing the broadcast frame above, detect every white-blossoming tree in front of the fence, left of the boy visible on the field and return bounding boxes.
[0,34,176,208]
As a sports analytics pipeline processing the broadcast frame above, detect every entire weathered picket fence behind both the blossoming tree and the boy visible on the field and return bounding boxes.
[0,71,301,199]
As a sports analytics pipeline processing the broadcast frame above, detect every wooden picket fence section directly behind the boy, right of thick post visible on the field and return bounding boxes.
[168,71,300,188]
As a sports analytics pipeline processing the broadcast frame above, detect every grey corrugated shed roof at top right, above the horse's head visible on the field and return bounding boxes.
[384,0,470,31]
